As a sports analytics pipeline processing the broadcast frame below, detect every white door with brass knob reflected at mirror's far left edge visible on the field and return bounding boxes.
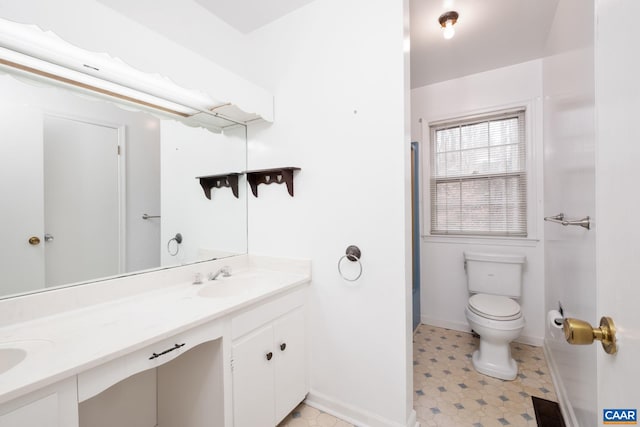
[0,101,44,295]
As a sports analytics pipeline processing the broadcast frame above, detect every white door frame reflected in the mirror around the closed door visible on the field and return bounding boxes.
[43,109,127,274]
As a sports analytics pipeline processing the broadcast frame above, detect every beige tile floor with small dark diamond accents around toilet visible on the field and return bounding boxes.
[278,325,557,427]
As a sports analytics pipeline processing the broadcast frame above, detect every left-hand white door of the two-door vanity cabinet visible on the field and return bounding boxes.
[232,324,276,427]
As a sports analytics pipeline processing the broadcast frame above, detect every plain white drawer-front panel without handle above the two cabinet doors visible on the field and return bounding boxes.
[231,287,306,340]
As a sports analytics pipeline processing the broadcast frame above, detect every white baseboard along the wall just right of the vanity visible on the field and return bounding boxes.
[304,390,420,427]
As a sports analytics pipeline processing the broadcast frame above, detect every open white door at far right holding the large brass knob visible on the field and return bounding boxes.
[596,0,640,425]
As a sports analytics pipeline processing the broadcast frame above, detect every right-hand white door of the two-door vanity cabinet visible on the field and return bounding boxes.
[273,307,308,422]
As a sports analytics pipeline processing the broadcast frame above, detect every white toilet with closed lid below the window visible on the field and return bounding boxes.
[464,252,526,380]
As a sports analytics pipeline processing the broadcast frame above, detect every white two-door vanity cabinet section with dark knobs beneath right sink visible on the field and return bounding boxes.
[231,289,309,427]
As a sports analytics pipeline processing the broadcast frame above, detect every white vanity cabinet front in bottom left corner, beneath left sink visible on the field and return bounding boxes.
[0,377,78,427]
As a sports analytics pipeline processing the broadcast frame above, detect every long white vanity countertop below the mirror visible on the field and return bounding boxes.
[0,268,310,403]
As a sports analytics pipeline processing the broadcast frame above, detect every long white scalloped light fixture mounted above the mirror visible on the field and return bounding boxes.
[0,18,248,131]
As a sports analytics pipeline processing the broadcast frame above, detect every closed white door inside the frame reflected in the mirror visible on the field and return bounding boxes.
[44,115,121,286]
